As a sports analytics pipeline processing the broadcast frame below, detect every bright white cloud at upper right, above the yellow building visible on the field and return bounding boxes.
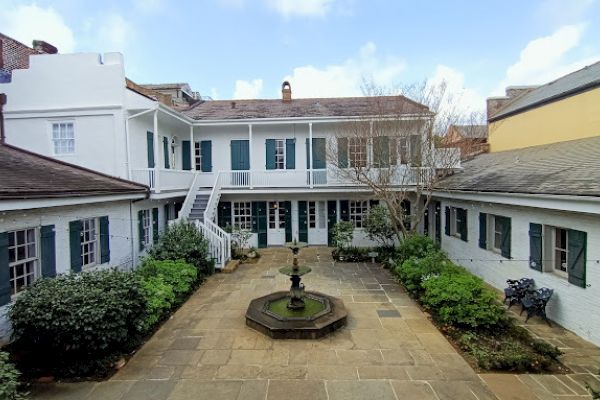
[494,24,597,94]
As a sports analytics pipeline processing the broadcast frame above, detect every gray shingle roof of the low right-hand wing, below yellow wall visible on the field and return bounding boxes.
[438,136,600,196]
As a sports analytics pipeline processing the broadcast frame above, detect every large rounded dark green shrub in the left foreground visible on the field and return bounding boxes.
[9,270,146,376]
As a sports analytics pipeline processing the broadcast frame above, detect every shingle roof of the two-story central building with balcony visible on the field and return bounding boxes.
[182,96,430,120]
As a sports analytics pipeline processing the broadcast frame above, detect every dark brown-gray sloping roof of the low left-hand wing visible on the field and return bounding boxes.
[0,144,148,200]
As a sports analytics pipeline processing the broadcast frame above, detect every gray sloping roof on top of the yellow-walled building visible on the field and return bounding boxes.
[490,61,600,121]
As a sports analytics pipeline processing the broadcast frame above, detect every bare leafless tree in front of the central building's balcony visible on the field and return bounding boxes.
[326,82,461,240]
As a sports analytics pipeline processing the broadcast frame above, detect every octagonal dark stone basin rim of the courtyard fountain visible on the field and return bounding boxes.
[246,291,348,339]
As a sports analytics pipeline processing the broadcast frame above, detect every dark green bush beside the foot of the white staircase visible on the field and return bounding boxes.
[148,221,215,278]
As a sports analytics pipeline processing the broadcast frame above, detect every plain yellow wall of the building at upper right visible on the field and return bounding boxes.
[488,88,600,152]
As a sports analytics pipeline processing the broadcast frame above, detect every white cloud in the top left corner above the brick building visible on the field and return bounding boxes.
[0,4,75,53]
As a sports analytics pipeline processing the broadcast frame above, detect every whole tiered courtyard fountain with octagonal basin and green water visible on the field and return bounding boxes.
[246,241,348,339]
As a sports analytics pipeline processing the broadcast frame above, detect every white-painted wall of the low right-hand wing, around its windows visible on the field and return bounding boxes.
[441,195,600,344]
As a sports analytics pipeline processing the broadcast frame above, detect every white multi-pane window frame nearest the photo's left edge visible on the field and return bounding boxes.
[7,228,41,299]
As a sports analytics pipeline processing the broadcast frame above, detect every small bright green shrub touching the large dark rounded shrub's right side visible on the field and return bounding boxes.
[142,276,175,332]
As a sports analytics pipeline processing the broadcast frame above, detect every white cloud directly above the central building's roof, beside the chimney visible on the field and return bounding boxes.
[283,42,406,98]
